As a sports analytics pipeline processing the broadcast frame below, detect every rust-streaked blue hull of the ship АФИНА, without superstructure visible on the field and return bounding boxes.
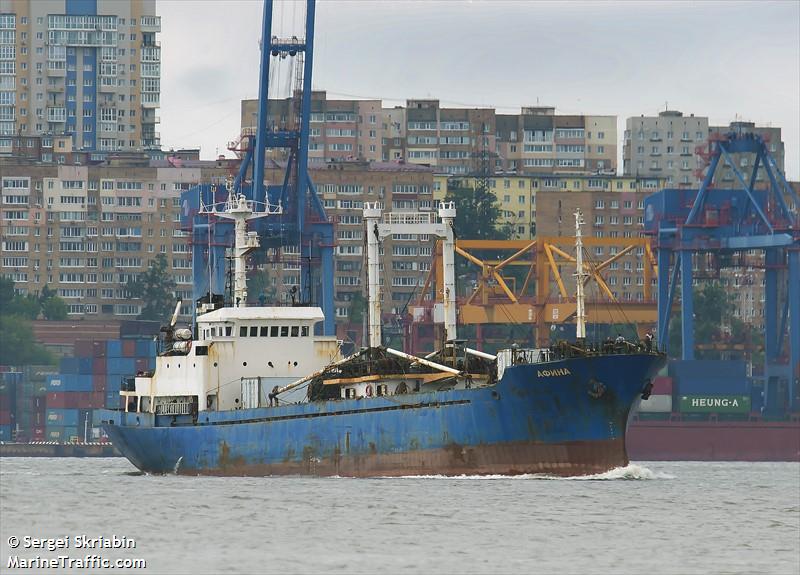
[101,354,665,477]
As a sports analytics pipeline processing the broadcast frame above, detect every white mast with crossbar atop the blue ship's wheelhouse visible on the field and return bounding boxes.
[200,183,283,307]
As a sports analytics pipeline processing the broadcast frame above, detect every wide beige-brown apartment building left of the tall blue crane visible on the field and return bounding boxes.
[0,155,235,319]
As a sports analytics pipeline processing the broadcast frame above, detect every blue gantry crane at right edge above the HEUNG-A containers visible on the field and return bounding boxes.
[645,132,800,414]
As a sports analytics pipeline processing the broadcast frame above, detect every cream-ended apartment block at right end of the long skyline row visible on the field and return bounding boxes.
[495,106,617,174]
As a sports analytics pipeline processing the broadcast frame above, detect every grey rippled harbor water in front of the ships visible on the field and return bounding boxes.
[0,458,800,575]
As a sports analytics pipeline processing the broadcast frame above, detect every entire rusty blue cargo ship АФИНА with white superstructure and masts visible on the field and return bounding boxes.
[100,196,666,477]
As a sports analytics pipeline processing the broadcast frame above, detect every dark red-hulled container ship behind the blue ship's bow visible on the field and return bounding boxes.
[628,360,800,461]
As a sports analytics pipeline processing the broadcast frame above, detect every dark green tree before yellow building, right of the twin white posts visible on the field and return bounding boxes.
[445,184,511,240]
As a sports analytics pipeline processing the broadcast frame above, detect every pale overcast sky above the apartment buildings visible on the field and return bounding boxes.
[156,0,800,180]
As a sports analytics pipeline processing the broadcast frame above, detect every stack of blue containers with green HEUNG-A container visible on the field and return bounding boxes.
[670,360,760,421]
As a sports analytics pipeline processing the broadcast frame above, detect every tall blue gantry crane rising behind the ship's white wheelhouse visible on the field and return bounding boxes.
[183,0,335,335]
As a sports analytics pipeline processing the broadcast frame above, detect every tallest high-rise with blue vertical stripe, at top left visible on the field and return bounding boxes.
[0,0,161,160]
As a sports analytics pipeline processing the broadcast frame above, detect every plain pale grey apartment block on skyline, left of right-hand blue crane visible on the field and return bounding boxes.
[623,110,708,188]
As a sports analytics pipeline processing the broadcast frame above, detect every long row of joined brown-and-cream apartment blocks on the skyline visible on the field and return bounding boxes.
[241,92,617,176]
